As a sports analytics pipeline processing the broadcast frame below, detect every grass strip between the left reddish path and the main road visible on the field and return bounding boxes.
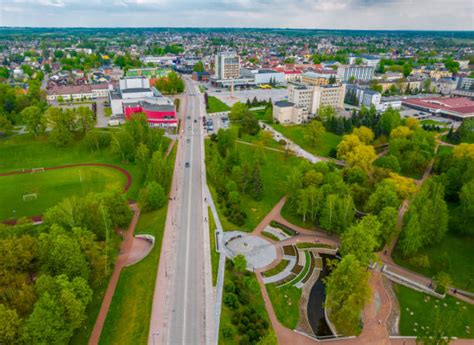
[100,146,177,345]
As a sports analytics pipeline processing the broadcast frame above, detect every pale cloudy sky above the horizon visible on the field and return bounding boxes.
[0,0,474,30]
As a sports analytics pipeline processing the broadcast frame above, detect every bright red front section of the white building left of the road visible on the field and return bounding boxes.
[123,101,178,127]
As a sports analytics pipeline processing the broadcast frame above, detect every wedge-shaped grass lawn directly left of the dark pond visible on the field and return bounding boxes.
[265,284,301,329]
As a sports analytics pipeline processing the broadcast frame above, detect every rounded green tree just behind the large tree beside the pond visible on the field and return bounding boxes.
[341,215,381,265]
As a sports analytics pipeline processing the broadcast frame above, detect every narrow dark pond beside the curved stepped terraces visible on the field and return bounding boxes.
[307,254,336,337]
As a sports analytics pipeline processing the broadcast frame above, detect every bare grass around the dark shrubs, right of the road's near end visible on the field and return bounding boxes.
[219,263,273,345]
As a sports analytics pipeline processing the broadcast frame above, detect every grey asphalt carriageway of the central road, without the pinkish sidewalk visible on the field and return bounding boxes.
[166,80,207,345]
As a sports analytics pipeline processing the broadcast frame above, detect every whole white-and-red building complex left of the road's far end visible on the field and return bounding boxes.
[109,76,178,127]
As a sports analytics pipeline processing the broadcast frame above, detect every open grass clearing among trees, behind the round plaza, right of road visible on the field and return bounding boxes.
[206,141,302,232]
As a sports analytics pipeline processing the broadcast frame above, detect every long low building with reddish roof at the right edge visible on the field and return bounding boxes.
[402,97,474,121]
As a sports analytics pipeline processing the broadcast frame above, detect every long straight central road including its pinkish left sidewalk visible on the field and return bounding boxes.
[149,78,214,345]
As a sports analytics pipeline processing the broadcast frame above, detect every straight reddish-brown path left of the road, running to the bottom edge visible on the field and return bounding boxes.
[89,204,140,345]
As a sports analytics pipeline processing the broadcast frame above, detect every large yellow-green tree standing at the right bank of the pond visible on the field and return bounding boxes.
[325,254,370,336]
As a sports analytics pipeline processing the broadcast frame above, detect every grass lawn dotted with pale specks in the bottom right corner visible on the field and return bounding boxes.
[394,284,474,338]
